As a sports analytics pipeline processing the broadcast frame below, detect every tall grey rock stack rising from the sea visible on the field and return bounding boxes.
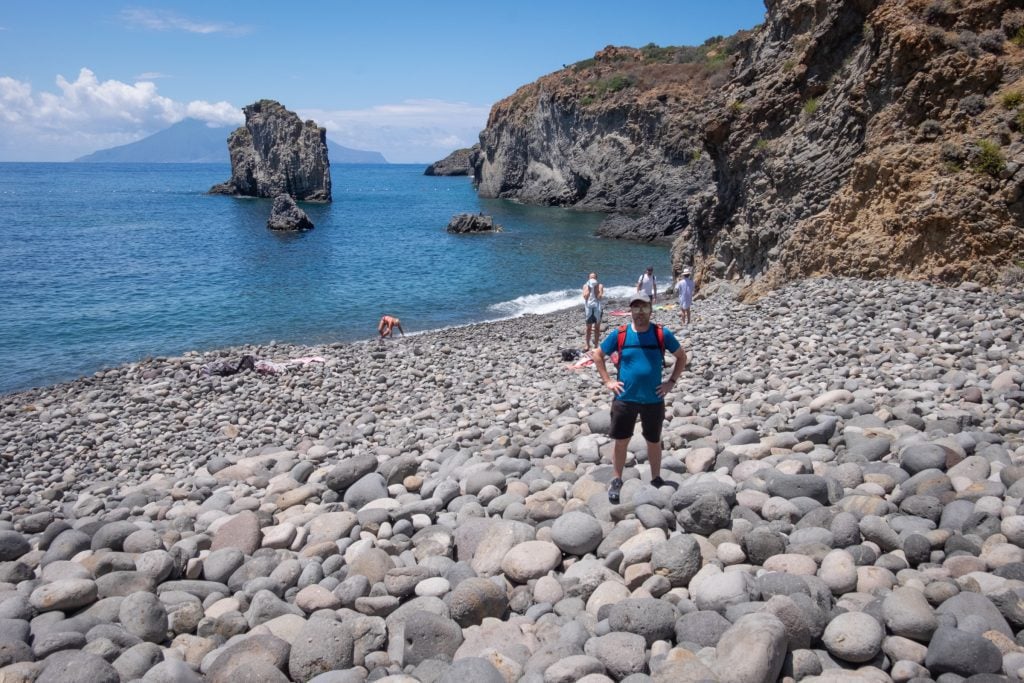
[210,99,331,202]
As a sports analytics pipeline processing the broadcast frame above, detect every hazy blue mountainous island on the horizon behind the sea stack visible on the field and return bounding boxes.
[75,119,388,164]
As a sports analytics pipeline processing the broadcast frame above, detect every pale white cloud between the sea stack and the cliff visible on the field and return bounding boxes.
[299,99,489,163]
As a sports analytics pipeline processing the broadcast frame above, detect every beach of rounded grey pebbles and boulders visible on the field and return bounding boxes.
[0,279,1024,683]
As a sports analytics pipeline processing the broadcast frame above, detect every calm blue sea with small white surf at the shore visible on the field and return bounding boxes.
[0,163,670,392]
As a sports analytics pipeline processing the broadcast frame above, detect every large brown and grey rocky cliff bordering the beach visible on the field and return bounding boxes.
[474,0,1024,291]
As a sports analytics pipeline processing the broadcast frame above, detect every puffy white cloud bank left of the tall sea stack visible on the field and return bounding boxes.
[0,69,244,161]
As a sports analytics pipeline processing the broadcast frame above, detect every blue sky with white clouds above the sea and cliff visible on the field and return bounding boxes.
[0,0,765,163]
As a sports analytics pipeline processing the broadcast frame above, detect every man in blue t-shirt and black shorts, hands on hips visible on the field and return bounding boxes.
[593,292,686,503]
